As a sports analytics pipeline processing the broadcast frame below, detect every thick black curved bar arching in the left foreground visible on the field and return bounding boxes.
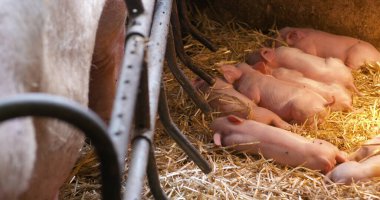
[0,93,121,200]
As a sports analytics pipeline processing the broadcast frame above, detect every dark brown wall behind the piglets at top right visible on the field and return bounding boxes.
[188,0,380,48]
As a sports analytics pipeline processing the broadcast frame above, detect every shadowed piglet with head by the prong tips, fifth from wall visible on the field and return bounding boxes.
[194,78,291,130]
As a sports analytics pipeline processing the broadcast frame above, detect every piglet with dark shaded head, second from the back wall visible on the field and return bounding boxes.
[246,47,361,95]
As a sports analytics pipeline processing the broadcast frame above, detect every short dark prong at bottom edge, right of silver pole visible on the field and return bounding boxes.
[147,148,168,200]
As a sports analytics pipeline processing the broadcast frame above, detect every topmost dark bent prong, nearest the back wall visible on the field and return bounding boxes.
[178,0,218,52]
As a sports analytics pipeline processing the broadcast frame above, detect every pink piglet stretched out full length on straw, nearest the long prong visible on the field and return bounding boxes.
[211,115,346,173]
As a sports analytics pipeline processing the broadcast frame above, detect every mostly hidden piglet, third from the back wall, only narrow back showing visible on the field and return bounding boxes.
[271,67,353,111]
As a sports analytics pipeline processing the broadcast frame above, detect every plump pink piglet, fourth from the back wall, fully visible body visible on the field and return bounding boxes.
[221,62,334,124]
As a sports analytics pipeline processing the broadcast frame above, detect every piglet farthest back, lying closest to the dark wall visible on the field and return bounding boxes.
[278,27,380,69]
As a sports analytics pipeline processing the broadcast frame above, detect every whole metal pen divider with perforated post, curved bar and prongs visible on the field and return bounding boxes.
[0,0,216,200]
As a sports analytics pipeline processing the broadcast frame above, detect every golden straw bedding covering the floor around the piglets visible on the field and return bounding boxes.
[61,9,380,199]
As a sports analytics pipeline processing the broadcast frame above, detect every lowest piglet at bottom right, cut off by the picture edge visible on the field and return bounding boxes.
[326,155,380,184]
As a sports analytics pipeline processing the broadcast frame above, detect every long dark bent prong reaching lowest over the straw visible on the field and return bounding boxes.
[158,82,212,174]
